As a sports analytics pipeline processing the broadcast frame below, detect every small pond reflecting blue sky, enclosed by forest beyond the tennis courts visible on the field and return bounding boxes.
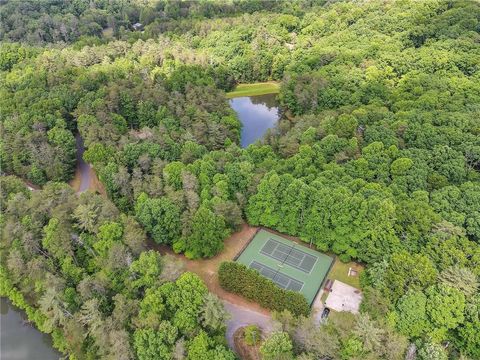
[230,94,280,147]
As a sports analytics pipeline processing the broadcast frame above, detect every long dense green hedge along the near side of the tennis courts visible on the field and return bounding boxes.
[218,262,310,316]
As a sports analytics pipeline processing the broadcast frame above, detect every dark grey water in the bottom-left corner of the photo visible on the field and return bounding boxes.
[0,298,62,360]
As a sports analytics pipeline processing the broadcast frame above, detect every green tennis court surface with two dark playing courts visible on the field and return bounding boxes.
[236,230,333,304]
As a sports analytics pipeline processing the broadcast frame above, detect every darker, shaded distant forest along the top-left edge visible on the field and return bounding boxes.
[0,0,288,44]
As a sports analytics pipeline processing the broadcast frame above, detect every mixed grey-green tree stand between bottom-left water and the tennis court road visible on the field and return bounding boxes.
[0,177,235,360]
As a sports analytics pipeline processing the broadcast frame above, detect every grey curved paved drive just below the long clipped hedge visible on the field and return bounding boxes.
[224,301,273,349]
